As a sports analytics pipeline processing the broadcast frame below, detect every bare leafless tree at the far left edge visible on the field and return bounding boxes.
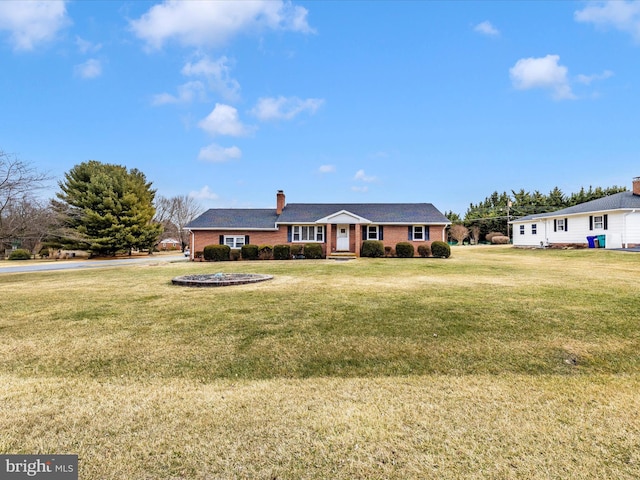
[0,150,50,251]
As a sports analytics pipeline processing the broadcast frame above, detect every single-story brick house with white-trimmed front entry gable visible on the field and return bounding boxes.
[185,190,451,259]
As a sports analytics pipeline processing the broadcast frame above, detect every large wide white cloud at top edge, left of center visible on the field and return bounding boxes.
[130,0,313,49]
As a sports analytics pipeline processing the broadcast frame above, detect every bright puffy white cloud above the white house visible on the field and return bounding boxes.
[509,55,575,100]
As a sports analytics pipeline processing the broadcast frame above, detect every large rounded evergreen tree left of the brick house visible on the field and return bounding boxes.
[56,160,162,255]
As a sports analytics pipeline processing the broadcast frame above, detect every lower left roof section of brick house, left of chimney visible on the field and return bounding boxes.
[185,208,278,230]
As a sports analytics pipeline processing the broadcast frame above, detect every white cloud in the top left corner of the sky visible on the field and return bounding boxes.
[0,0,71,50]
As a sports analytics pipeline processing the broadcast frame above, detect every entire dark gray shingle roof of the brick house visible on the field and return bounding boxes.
[186,203,450,230]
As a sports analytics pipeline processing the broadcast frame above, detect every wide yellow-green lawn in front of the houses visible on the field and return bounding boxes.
[0,247,640,480]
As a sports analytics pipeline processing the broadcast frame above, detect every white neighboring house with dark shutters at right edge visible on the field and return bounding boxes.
[511,177,640,248]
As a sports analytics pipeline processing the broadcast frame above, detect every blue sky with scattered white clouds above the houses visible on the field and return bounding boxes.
[0,0,640,214]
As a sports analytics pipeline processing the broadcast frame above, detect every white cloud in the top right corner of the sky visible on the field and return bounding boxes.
[573,0,640,41]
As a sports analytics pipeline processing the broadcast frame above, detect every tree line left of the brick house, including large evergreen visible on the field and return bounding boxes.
[0,151,203,256]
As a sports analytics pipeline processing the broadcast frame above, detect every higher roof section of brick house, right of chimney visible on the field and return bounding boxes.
[277,203,451,225]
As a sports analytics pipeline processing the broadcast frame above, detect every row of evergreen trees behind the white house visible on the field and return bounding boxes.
[445,186,627,242]
